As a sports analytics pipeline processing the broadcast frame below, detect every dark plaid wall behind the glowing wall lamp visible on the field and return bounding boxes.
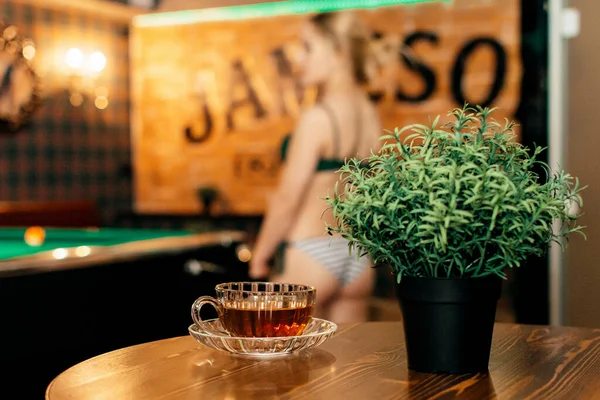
[0,1,131,225]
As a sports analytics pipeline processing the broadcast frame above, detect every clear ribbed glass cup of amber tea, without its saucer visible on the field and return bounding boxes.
[192,282,317,337]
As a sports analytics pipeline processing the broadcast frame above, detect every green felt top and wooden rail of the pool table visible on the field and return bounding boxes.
[0,227,245,277]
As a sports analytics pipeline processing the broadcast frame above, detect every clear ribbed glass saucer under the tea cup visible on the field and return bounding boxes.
[188,318,337,357]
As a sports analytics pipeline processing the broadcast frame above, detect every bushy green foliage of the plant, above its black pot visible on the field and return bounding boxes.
[324,105,585,282]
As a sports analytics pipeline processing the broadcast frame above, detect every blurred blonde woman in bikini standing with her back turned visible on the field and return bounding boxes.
[250,13,381,323]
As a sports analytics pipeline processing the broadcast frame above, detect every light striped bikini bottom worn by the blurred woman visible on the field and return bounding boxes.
[287,237,370,286]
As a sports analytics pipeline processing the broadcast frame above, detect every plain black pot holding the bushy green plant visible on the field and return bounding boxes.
[396,276,502,374]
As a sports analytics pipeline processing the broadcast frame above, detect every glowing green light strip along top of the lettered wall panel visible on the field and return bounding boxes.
[133,0,440,27]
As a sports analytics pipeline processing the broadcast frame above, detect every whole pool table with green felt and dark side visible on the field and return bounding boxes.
[0,228,248,399]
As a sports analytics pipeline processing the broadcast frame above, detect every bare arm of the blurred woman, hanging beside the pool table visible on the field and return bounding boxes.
[250,108,330,278]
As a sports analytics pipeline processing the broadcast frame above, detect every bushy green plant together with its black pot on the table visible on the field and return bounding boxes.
[326,105,582,373]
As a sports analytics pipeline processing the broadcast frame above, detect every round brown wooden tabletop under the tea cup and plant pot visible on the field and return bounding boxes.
[46,322,600,400]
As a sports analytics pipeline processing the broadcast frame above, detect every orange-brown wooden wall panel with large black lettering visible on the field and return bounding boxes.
[131,0,521,215]
